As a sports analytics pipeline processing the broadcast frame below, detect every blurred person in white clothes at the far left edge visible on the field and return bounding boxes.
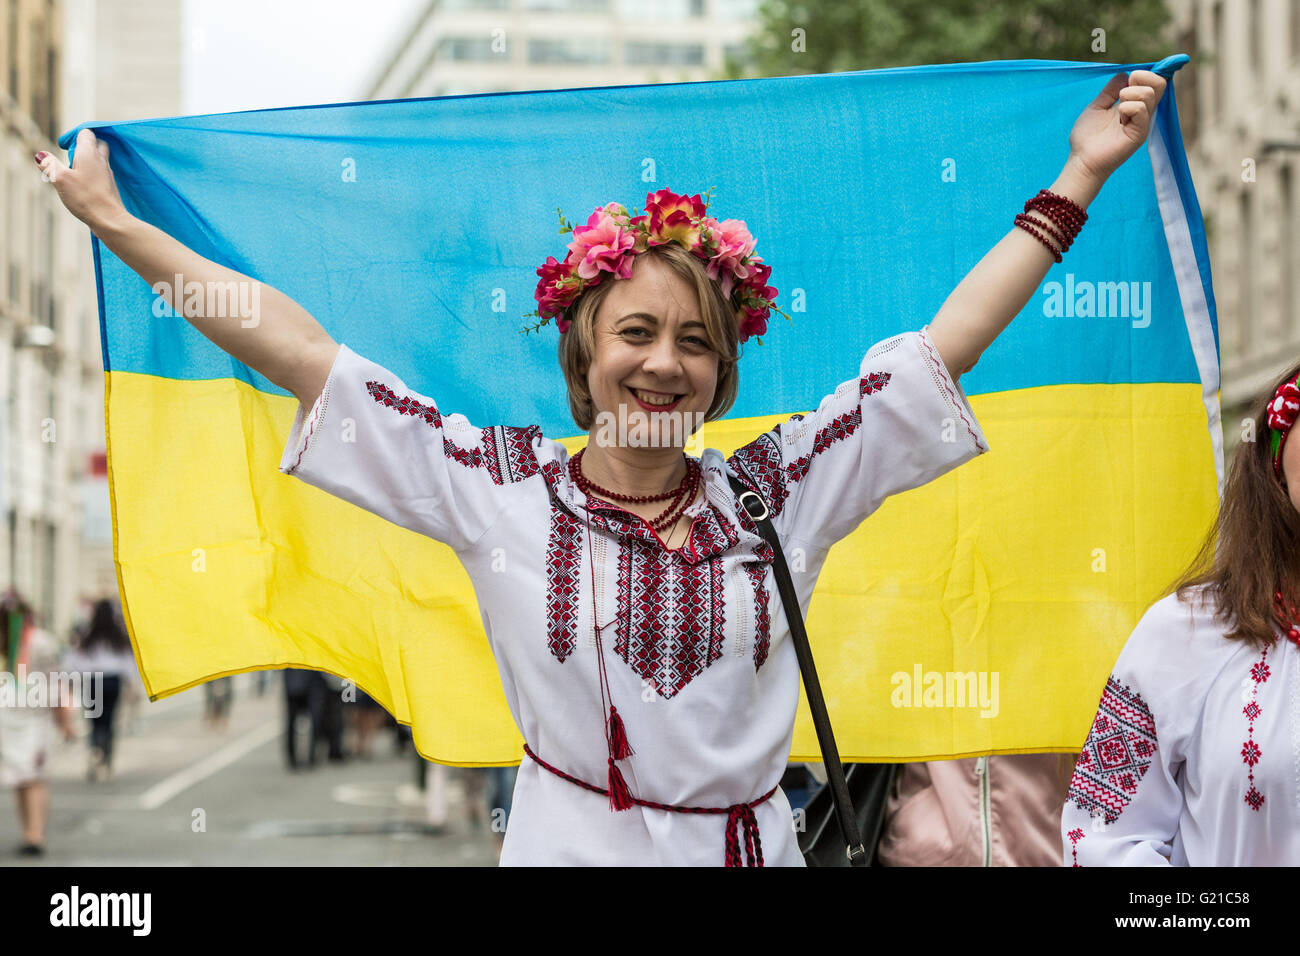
[0,589,75,856]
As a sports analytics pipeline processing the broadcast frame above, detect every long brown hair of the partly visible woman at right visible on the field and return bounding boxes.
[1166,364,1300,650]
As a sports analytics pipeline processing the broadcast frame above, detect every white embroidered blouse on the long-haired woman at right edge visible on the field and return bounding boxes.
[1061,588,1300,866]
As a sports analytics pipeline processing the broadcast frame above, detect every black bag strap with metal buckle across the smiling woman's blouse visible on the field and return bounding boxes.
[727,473,867,866]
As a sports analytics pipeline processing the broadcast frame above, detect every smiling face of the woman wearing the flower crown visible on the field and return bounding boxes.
[586,255,722,447]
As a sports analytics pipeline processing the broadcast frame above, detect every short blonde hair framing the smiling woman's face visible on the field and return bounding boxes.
[559,242,741,432]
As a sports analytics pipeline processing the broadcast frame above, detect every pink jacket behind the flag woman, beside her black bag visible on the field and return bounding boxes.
[878,753,1074,866]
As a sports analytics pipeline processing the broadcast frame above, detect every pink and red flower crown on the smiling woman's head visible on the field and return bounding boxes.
[521,186,790,345]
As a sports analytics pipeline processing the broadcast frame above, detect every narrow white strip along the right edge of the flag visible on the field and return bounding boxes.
[1148,124,1223,498]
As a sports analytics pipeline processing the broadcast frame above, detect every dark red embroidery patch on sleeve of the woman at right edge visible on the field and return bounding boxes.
[1067,675,1156,823]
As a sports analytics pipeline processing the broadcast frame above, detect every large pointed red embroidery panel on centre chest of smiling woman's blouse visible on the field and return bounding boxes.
[614,541,727,698]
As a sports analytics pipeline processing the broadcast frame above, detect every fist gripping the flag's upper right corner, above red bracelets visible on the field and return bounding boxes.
[1070,70,1169,183]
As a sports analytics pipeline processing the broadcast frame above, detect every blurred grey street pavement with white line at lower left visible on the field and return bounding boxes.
[0,672,497,866]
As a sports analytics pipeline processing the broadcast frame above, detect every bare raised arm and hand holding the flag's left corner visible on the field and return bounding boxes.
[36,129,338,408]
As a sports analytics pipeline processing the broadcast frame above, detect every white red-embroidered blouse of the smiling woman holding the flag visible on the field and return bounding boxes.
[280,329,987,866]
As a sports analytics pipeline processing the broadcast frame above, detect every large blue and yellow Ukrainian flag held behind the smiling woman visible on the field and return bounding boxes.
[60,56,1222,765]
